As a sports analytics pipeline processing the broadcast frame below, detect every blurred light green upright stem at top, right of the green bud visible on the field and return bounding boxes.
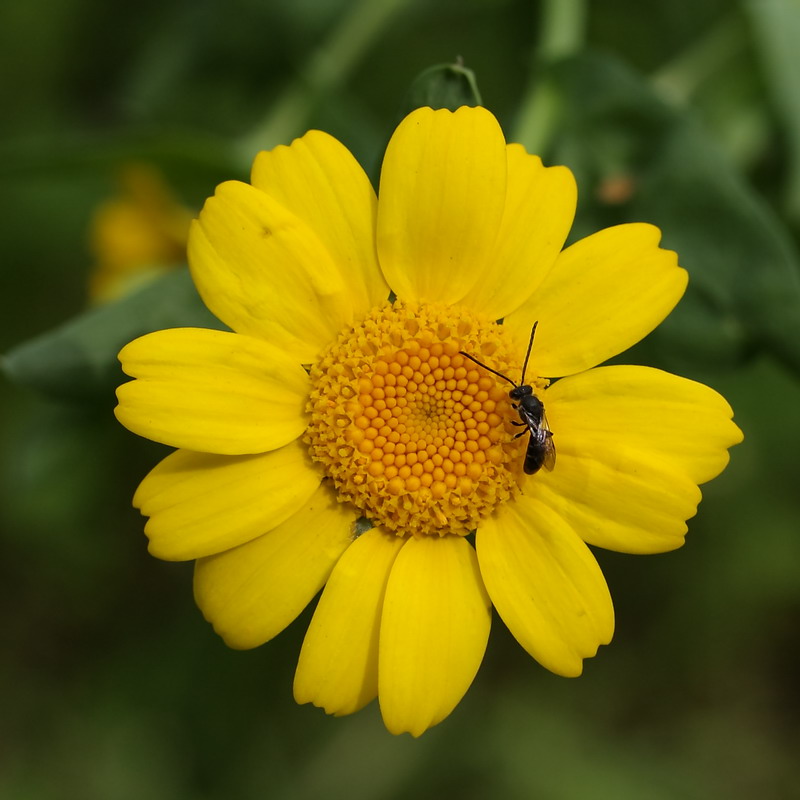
[511,0,588,153]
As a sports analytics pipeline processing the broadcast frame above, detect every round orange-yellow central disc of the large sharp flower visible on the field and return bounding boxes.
[305,302,527,536]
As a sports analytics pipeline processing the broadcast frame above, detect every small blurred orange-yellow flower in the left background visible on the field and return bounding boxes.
[89,164,192,303]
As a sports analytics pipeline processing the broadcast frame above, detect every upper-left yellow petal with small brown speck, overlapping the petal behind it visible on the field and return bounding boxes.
[189,181,353,364]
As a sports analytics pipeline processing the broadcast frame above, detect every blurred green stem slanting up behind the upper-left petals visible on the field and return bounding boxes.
[236,0,415,164]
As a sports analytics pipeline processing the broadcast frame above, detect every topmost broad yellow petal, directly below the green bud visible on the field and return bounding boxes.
[378,108,506,303]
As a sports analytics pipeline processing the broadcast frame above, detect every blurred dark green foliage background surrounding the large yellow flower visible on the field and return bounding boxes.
[0,0,800,800]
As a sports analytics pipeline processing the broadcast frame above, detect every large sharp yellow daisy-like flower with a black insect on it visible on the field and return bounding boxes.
[116,108,742,736]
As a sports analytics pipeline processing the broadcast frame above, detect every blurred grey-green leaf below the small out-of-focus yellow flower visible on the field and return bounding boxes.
[2,268,225,401]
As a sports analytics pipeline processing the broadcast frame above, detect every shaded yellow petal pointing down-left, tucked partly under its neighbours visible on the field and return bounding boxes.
[194,484,355,649]
